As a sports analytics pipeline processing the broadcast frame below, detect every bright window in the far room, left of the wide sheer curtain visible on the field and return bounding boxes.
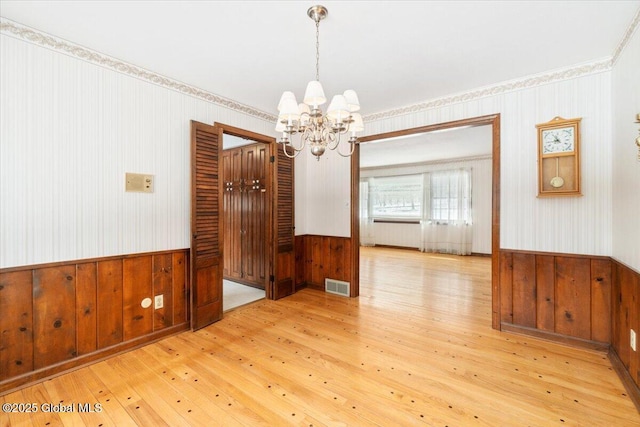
[369,175,423,219]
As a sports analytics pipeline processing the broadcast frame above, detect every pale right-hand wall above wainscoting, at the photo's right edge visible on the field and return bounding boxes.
[612,24,640,272]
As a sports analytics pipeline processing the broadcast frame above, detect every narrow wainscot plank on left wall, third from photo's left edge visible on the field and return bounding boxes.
[76,262,98,356]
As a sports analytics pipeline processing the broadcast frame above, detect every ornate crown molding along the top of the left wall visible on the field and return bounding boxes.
[0,17,277,122]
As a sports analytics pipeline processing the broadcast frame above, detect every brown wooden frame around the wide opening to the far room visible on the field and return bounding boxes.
[351,113,500,330]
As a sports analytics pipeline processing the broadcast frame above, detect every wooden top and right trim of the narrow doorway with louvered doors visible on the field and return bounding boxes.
[214,122,277,300]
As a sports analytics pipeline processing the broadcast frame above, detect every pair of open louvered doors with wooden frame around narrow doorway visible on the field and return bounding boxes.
[189,120,295,330]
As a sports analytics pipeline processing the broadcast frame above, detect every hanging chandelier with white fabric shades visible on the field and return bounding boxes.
[276,6,364,160]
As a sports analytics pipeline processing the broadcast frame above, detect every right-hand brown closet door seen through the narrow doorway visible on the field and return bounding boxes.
[242,144,269,289]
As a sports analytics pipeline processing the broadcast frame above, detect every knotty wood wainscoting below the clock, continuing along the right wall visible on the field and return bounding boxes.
[500,250,640,409]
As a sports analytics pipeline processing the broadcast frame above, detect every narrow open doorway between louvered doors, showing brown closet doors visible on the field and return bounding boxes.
[221,133,271,311]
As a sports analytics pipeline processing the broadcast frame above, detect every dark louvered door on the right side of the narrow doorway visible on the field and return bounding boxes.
[267,142,295,299]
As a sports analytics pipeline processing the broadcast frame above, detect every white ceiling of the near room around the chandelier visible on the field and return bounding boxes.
[0,0,640,116]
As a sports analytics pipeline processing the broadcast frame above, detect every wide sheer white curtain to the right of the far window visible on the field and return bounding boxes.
[420,169,473,255]
